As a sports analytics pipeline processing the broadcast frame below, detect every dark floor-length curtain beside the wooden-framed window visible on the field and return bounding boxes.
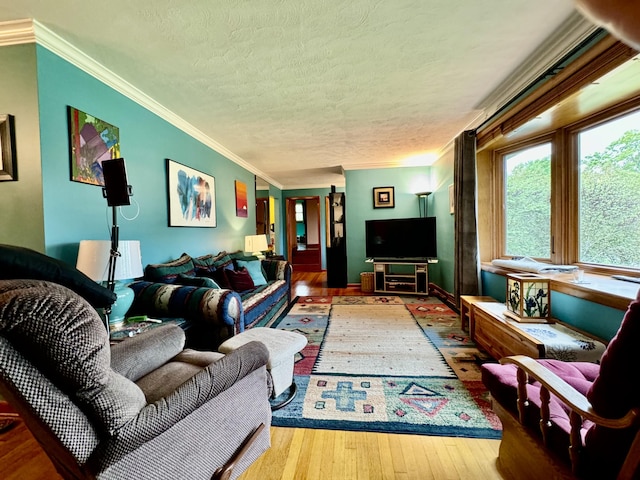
[453,130,480,305]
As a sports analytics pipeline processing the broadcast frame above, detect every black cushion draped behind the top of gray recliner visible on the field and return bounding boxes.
[0,245,116,308]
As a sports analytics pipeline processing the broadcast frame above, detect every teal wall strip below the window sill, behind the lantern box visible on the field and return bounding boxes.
[482,271,625,341]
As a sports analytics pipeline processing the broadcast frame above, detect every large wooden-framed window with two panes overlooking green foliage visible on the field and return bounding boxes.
[494,102,640,273]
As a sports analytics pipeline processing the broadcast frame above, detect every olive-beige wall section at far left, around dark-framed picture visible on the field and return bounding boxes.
[0,44,44,252]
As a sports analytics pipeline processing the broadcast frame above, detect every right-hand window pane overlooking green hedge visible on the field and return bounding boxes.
[576,111,640,268]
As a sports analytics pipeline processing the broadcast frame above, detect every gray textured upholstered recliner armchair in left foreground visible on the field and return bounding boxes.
[0,280,271,480]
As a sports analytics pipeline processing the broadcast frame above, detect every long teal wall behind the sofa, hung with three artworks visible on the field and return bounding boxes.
[32,46,256,264]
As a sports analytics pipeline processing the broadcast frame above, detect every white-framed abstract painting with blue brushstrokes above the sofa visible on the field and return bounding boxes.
[167,159,217,227]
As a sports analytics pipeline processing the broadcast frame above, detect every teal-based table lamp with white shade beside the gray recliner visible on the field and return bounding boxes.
[76,240,143,331]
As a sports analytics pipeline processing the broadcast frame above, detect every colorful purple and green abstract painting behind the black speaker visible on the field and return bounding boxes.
[69,107,120,185]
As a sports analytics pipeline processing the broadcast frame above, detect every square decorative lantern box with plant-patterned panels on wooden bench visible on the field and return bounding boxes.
[505,273,551,323]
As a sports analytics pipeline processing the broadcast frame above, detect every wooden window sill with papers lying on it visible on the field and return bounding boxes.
[482,262,640,310]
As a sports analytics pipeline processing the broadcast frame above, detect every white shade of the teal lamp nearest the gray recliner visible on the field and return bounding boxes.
[76,240,143,282]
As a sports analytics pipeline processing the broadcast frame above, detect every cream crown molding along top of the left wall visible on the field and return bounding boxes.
[0,19,282,189]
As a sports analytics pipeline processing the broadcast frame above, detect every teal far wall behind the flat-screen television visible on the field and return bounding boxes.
[345,167,440,283]
